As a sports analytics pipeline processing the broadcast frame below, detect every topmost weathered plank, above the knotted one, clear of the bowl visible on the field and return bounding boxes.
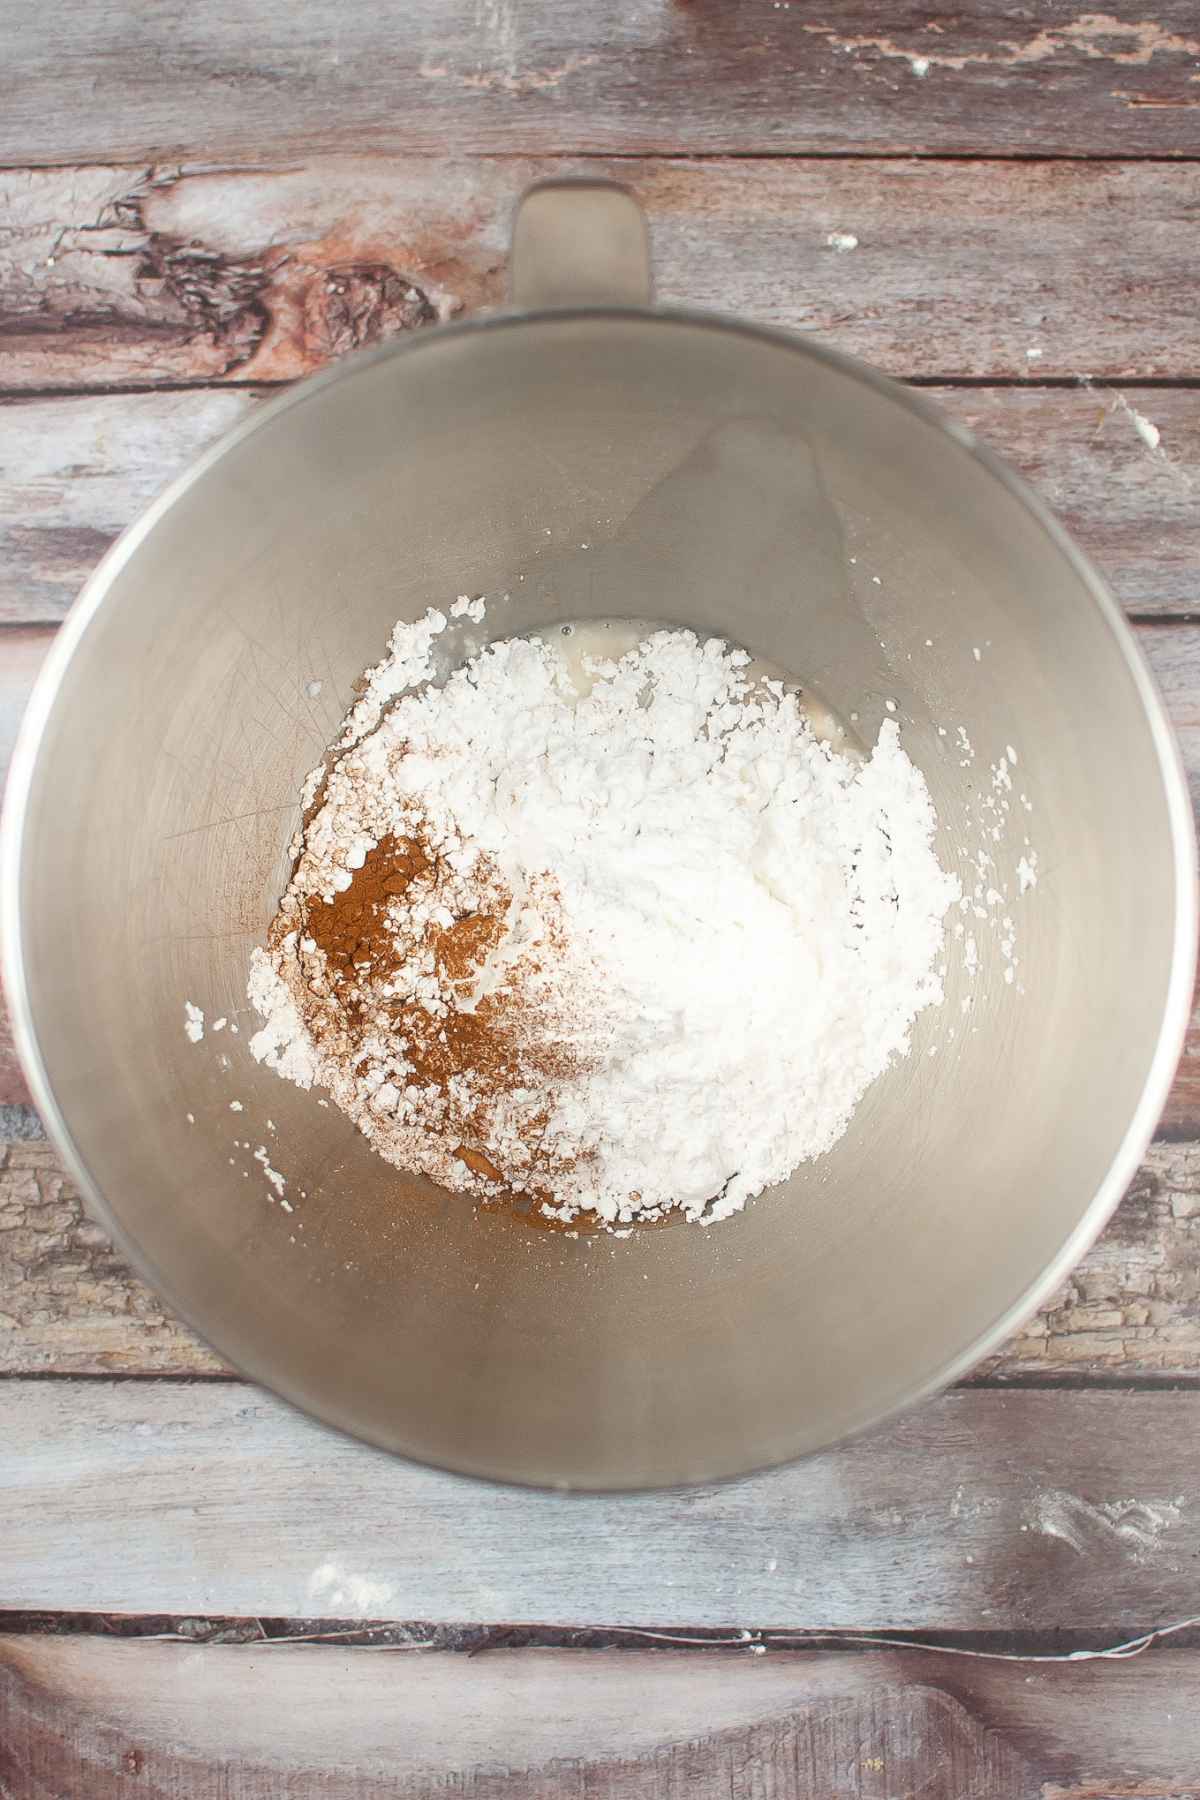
[0,0,1200,164]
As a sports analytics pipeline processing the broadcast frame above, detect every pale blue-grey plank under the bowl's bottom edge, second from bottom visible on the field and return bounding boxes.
[0,1377,1200,1631]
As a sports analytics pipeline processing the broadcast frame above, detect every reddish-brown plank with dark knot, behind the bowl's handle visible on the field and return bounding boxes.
[0,159,1200,389]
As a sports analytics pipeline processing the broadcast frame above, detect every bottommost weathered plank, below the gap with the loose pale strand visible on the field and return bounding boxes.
[0,1636,1200,1800]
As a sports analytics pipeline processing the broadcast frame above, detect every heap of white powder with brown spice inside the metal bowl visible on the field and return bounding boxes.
[248,608,959,1224]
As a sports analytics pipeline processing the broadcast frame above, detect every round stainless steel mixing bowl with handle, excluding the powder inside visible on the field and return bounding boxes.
[4,189,1195,1489]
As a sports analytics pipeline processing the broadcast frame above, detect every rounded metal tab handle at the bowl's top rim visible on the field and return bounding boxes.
[509,176,649,311]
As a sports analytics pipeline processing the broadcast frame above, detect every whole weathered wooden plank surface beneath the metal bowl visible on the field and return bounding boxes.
[0,0,1200,1800]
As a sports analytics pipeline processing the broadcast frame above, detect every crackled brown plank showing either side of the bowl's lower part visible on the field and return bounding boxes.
[0,1141,1200,1379]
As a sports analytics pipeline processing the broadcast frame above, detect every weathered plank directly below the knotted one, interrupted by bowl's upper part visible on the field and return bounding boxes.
[0,387,1200,626]
